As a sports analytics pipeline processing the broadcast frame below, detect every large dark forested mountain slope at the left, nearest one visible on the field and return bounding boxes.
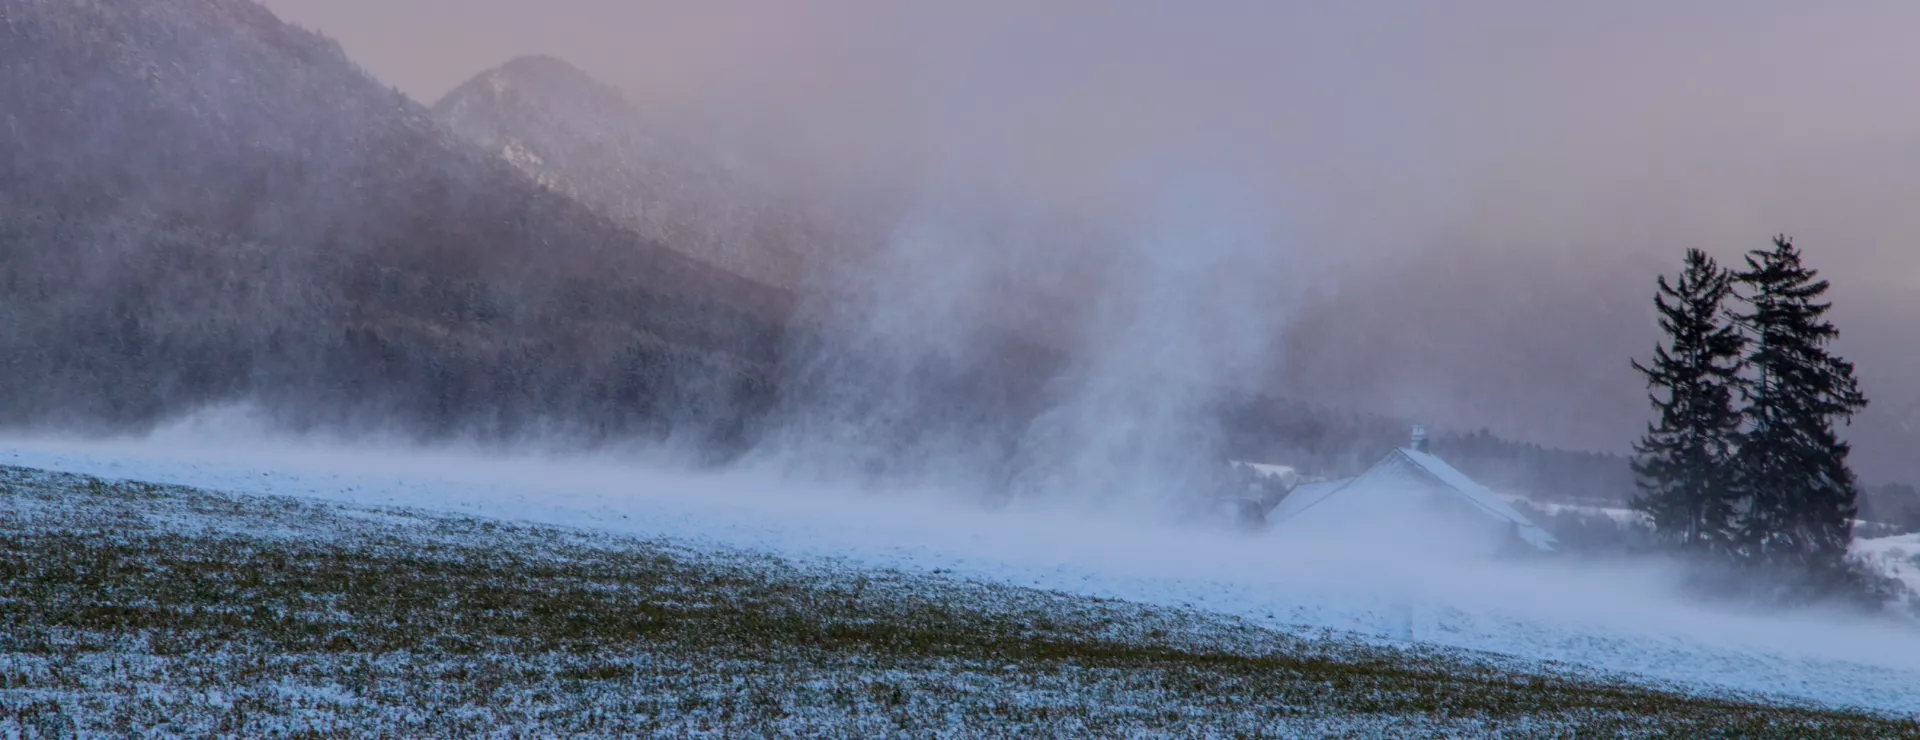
[0,0,791,445]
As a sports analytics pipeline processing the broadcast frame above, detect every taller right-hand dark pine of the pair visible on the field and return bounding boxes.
[1736,236,1866,577]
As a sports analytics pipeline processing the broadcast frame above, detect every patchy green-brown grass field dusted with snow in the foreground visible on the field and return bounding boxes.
[0,469,1920,738]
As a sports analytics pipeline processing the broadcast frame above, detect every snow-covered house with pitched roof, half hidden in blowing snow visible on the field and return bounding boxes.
[1265,429,1557,554]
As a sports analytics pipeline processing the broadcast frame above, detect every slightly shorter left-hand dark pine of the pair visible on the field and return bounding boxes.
[1634,250,1745,554]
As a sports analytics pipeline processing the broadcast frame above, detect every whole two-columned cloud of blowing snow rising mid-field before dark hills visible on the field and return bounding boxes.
[760,168,1306,506]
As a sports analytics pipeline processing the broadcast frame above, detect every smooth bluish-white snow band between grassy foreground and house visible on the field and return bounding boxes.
[11,434,1920,717]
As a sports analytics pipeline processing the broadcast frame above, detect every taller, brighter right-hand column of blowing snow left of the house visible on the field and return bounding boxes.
[1014,177,1298,504]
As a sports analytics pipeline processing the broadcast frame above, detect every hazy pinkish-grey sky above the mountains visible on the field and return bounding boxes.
[265,0,1920,472]
